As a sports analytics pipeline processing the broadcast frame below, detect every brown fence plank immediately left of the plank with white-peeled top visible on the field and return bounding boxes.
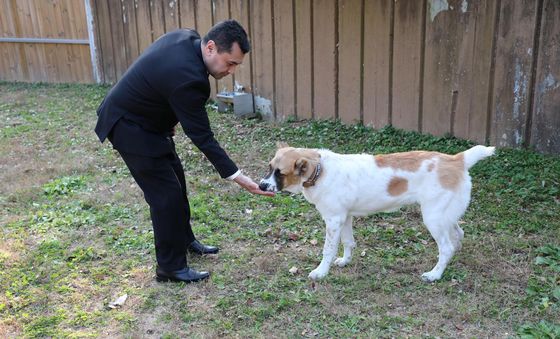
[390,1,425,131]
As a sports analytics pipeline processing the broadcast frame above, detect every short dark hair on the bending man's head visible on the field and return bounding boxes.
[202,20,251,54]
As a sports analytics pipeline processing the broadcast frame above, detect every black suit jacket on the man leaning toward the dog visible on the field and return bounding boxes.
[95,29,238,178]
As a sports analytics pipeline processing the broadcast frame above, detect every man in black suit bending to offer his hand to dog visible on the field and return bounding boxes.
[95,20,270,283]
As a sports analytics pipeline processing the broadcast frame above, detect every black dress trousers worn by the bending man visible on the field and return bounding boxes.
[109,119,195,271]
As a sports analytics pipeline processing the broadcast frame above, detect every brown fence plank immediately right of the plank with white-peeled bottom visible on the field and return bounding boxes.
[273,1,295,119]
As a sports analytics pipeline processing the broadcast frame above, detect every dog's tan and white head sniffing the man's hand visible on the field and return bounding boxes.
[259,143,321,193]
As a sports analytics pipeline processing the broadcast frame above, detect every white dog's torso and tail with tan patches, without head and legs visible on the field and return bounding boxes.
[304,146,494,218]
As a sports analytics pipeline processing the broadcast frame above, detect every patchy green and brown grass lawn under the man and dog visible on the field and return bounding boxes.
[0,83,560,338]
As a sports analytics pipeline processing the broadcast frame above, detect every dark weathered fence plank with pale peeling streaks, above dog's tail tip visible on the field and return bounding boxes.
[490,1,536,147]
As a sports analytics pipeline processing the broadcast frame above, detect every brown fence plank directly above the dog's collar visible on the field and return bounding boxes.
[312,0,337,119]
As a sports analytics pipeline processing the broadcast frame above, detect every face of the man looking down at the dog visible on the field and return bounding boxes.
[202,40,245,79]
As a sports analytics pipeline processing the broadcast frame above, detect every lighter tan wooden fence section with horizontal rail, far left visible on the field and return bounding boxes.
[0,0,95,83]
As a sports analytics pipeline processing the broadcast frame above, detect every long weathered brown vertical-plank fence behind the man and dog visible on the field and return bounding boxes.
[0,0,560,154]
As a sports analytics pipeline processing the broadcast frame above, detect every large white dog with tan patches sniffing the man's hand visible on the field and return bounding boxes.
[259,144,494,282]
